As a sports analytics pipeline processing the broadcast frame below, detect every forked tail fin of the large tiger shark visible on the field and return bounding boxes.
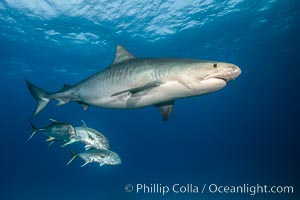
[26,79,50,119]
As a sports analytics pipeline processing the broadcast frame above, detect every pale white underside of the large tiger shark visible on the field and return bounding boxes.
[93,78,226,109]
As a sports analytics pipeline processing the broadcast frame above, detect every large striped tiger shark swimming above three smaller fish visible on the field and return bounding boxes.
[26,45,241,121]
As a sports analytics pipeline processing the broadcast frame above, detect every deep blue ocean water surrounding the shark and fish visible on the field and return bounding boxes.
[0,0,300,200]
